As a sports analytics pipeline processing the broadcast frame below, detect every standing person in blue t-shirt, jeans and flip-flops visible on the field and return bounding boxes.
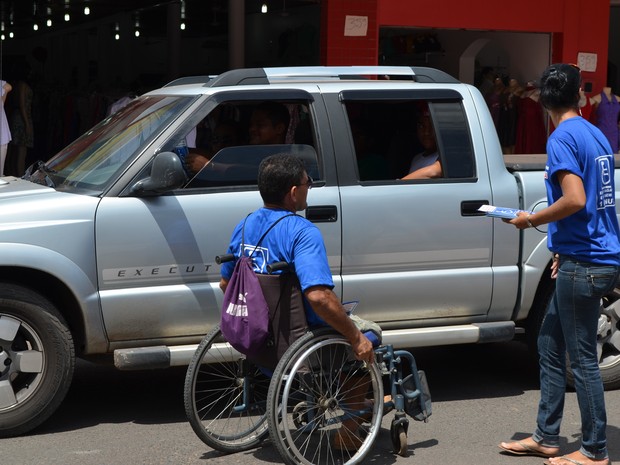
[499,63,620,465]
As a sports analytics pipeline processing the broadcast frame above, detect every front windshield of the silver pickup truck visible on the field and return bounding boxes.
[25,95,193,195]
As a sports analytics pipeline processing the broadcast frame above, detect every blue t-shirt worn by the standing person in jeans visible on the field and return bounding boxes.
[545,116,620,265]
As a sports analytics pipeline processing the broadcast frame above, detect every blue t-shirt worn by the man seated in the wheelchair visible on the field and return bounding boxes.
[221,208,334,326]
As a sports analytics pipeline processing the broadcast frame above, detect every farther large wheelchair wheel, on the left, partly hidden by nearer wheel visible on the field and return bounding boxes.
[184,325,270,452]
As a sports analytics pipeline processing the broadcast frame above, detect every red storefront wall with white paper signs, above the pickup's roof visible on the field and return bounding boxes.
[321,0,610,92]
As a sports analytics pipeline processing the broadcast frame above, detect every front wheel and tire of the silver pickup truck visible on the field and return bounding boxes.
[0,283,75,437]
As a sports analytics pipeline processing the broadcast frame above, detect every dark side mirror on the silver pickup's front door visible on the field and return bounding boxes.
[130,152,187,195]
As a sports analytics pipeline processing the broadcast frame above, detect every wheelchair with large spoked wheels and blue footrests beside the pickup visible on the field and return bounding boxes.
[184,258,431,465]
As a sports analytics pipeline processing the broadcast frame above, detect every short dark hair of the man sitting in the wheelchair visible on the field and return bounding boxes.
[258,153,306,205]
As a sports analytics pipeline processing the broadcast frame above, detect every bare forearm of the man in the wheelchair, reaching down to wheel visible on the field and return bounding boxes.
[306,284,375,363]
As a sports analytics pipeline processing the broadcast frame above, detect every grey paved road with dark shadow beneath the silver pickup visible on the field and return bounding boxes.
[0,342,620,465]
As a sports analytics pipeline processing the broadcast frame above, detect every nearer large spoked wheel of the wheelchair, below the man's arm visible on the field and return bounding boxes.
[267,328,383,465]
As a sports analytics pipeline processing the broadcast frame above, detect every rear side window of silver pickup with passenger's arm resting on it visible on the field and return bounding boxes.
[346,100,474,181]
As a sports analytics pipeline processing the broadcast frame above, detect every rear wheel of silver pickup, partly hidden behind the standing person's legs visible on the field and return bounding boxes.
[526,283,620,391]
